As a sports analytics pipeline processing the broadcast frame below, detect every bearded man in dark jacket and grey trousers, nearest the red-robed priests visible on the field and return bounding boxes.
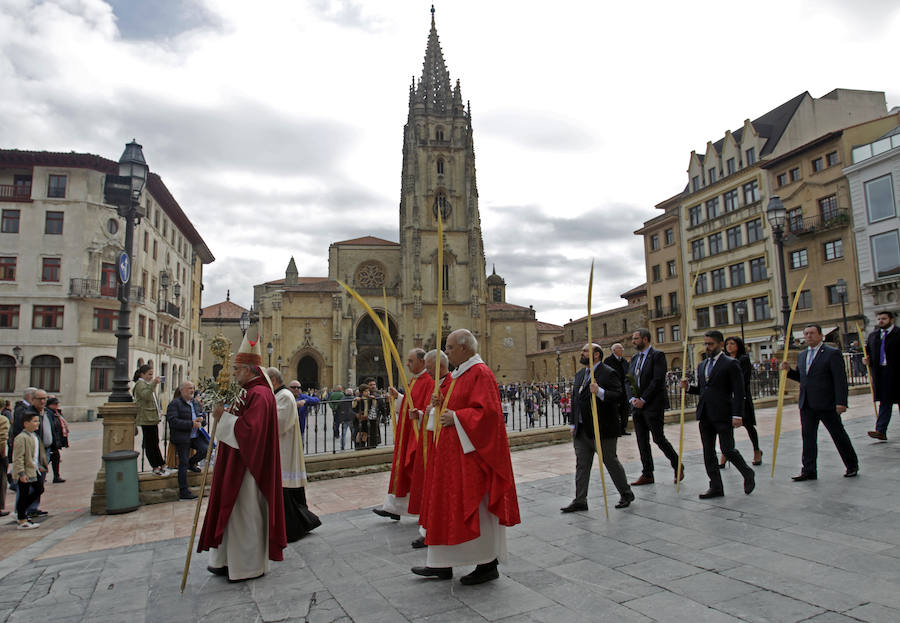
[560,344,634,513]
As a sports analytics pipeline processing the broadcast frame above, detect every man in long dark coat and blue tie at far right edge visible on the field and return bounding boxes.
[866,311,900,441]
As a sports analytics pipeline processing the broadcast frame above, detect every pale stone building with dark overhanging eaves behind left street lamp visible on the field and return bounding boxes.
[0,149,214,420]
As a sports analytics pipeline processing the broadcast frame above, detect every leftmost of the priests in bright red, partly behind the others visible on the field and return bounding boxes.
[372,348,434,520]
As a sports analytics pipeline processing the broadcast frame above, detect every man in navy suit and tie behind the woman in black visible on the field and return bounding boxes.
[781,324,859,482]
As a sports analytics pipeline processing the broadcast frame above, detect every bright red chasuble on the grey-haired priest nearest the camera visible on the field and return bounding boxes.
[420,363,521,545]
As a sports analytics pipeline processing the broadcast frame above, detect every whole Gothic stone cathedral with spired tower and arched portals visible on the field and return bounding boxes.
[253,9,562,387]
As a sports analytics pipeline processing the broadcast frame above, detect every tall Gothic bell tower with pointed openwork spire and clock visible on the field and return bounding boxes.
[400,6,488,357]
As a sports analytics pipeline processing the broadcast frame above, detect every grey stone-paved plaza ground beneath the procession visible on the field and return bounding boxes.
[0,396,900,623]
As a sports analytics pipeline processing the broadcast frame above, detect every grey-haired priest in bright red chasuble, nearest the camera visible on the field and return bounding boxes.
[412,329,520,584]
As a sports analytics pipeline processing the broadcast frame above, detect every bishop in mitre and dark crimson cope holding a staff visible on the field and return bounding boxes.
[197,335,287,582]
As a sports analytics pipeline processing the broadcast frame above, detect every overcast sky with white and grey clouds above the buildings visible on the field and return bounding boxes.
[0,0,900,324]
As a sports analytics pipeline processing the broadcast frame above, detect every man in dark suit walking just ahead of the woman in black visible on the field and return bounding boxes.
[681,331,756,500]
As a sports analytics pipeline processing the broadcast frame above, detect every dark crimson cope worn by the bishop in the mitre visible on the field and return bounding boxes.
[197,377,287,560]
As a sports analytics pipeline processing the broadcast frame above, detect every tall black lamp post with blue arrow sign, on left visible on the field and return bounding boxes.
[104,139,150,402]
